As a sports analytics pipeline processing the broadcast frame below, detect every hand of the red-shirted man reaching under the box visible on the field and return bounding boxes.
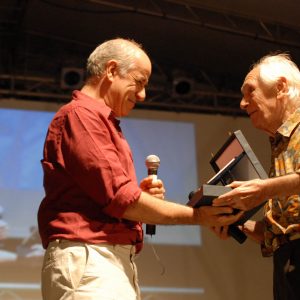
[195,206,243,227]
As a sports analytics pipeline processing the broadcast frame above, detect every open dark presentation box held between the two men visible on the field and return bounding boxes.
[187,130,268,243]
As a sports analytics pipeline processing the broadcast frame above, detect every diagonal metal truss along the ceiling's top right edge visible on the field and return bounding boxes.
[86,0,300,48]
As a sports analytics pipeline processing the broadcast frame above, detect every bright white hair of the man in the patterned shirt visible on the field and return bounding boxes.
[252,53,300,100]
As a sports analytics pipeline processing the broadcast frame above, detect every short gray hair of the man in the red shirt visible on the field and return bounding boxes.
[87,38,145,77]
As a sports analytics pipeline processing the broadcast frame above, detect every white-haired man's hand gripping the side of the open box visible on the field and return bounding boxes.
[213,179,266,211]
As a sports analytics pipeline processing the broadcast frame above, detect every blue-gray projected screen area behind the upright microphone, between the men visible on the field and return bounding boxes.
[121,119,201,245]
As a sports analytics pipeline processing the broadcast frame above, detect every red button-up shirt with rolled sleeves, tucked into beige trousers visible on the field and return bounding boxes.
[38,91,143,252]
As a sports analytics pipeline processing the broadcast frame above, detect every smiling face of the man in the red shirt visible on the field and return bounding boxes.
[108,51,151,117]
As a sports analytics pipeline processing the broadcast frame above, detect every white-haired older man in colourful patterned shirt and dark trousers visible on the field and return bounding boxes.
[214,54,300,300]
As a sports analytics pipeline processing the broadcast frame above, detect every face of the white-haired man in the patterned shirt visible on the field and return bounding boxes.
[240,68,282,135]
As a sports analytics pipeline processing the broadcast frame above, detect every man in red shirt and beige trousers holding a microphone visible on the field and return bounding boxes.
[38,38,240,300]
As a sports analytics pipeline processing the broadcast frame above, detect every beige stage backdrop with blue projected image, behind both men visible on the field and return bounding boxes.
[0,100,272,300]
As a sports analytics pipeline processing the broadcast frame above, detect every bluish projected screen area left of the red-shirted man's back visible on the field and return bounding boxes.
[0,109,53,238]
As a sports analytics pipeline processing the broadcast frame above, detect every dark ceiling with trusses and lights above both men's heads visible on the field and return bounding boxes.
[0,0,300,115]
